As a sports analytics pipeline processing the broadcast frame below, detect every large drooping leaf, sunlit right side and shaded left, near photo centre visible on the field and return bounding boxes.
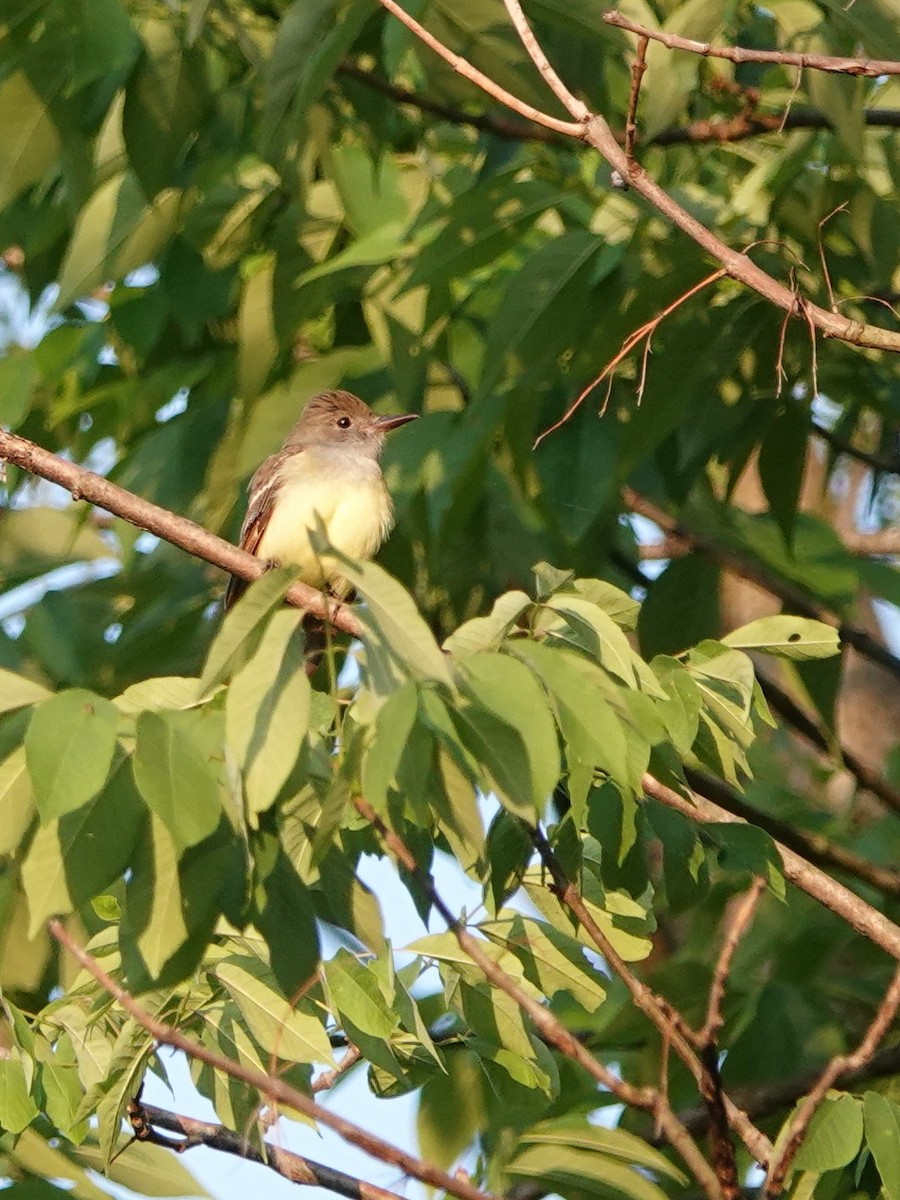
[458,650,560,818]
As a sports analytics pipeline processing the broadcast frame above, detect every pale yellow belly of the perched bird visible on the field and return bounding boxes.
[257,473,391,592]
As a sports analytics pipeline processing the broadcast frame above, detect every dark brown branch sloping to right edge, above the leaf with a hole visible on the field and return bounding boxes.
[622,487,900,678]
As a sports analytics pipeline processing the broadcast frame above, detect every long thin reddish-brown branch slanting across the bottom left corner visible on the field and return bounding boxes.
[47,918,490,1200]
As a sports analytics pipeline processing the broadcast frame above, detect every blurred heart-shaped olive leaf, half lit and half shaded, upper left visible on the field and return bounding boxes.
[56,172,181,308]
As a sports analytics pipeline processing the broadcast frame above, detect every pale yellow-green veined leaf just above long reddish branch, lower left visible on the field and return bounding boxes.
[215,955,335,1066]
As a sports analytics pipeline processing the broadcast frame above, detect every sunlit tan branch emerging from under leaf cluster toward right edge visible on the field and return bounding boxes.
[642,773,900,960]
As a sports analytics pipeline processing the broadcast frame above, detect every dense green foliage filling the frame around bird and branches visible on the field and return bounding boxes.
[0,0,900,1200]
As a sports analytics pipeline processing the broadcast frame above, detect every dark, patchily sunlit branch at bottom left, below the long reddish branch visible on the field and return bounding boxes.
[126,1100,403,1200]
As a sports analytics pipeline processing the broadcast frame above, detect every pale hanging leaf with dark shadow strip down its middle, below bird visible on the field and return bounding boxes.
[226,608,311,814]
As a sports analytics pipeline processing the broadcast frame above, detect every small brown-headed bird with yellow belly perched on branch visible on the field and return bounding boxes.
[224,391,418,612]
